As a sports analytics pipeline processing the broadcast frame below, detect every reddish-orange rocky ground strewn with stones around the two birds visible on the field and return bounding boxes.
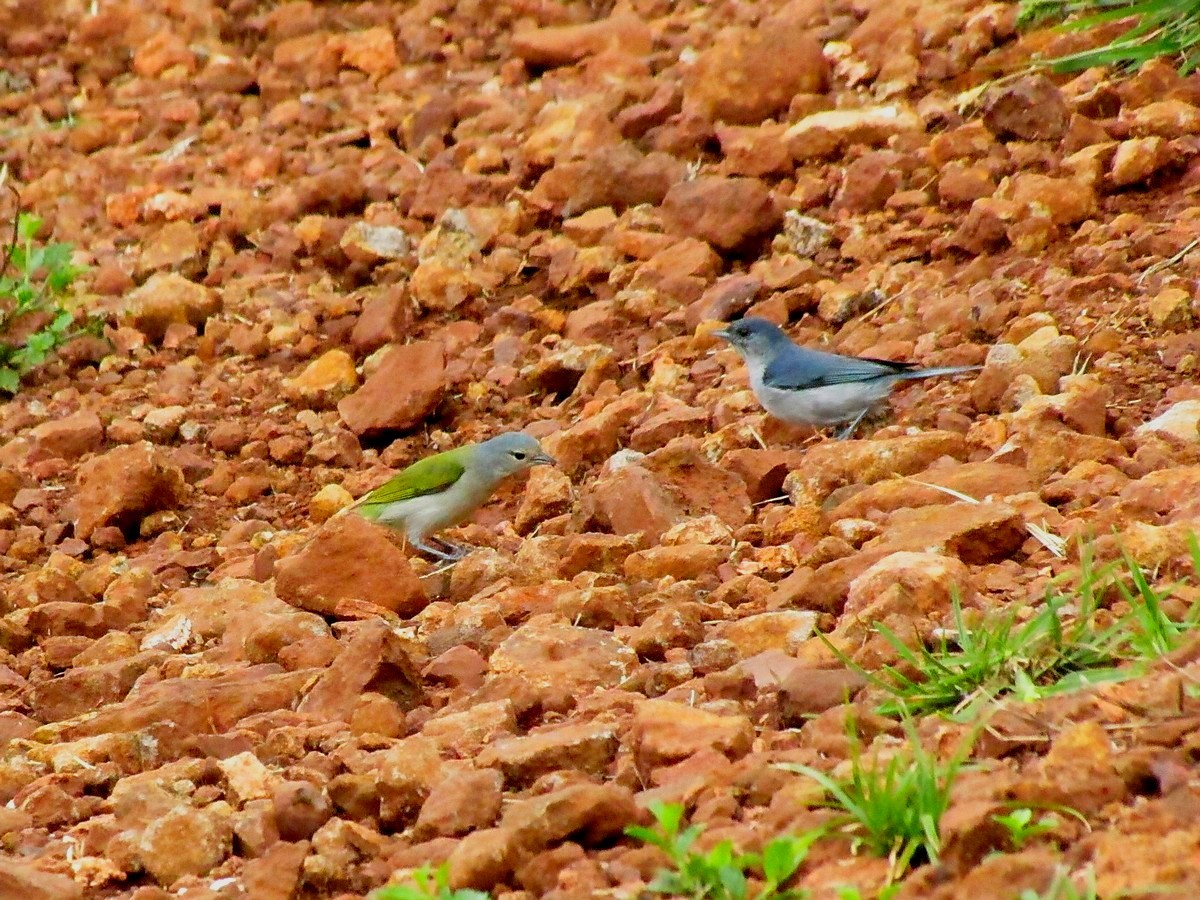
[0,0,1200,900]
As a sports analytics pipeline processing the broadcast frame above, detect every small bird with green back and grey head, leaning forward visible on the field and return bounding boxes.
[350,431,558,560]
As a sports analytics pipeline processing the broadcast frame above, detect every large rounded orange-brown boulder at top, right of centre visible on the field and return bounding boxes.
[684,17,829,125]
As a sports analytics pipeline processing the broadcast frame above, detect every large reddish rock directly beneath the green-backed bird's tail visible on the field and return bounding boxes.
[275,512,428,617]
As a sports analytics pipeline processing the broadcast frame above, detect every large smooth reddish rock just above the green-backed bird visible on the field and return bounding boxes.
[337,341,445,436]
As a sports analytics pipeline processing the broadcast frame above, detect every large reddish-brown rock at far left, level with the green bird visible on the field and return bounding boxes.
[74,442,186,540]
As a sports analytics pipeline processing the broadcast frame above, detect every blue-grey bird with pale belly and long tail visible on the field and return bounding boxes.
[713,316,983,440]
